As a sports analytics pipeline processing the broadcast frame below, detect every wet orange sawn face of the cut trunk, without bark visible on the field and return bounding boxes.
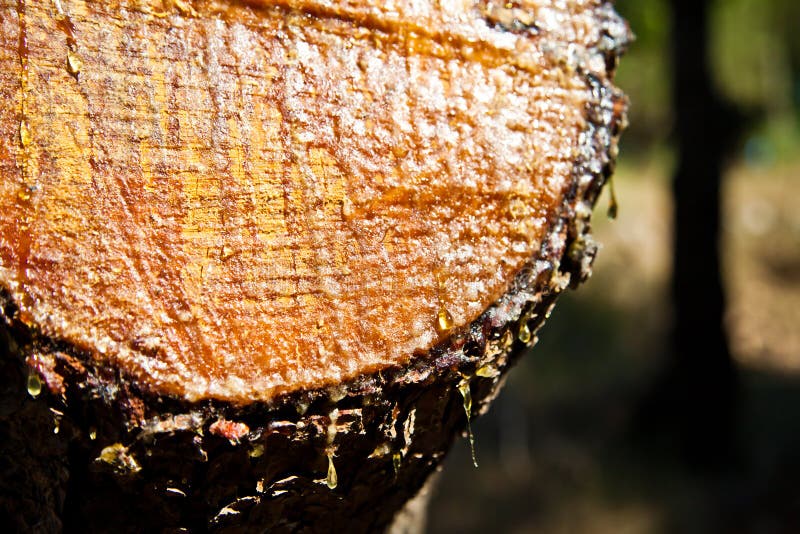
[0,0,603,401]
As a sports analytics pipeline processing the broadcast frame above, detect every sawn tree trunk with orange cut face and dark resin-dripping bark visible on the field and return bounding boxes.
[0,0,629,532]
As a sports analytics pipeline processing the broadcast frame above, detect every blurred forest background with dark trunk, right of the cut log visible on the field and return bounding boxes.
[428,0,800,533]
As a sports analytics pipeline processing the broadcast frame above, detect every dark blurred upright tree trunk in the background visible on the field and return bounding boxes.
[639,0,739,469]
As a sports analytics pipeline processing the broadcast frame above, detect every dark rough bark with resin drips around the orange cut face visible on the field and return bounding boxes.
[0,4,629,532]
